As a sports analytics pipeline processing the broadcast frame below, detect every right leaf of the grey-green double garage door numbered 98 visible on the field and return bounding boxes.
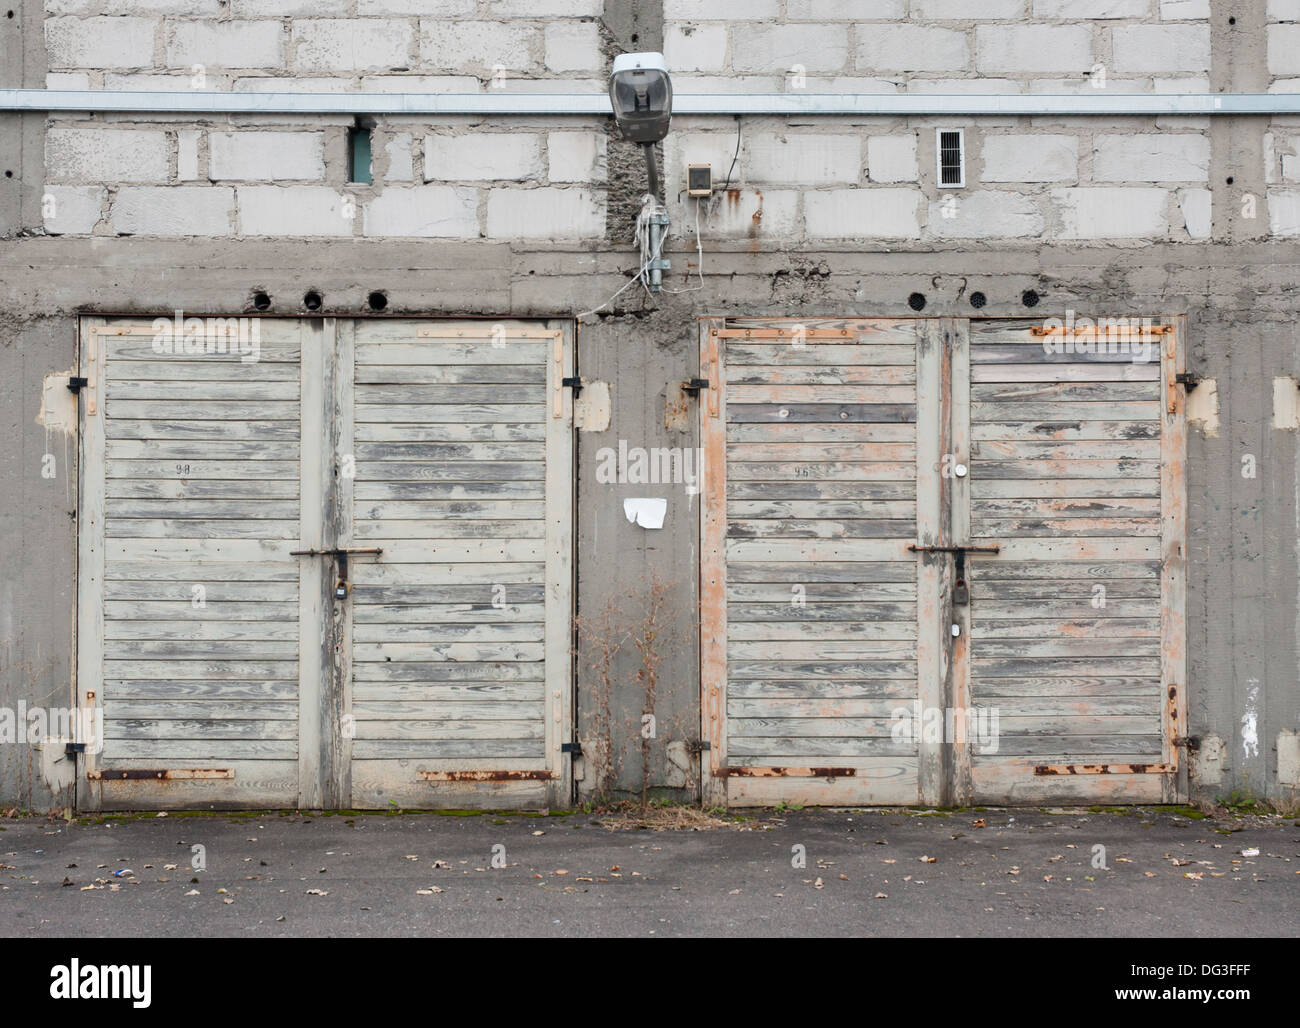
[350,321,573,807]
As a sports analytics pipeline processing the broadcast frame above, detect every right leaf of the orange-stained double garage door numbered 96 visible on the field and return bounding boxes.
[954,318,1186,802]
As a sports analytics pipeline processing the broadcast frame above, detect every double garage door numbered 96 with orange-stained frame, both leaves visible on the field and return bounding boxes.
[701,318,1186,804]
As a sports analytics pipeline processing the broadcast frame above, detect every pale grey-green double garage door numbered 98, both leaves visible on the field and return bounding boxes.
[78,318,572,808]
